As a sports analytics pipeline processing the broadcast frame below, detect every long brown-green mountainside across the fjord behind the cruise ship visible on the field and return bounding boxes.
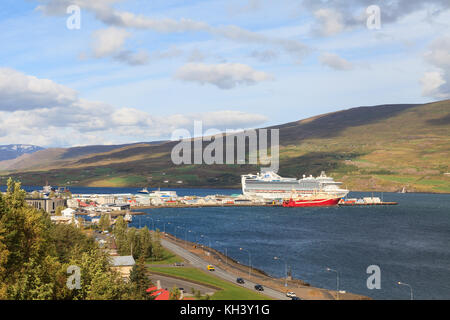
[0,100,450,192]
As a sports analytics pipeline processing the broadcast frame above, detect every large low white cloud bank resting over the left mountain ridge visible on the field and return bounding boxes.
[0,69,267,146]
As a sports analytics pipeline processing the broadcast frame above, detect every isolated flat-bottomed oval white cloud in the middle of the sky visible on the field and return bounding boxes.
[175,63,273,89]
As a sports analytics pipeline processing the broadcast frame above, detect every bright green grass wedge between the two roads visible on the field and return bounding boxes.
[149,267,270,300]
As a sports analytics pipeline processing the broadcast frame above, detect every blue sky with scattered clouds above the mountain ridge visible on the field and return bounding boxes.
[0,0,450,147]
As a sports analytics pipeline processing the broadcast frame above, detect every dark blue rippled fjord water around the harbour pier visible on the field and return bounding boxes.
[7,187,450,299]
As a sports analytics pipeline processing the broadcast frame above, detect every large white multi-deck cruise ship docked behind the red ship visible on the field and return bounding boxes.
[241,171,349,199]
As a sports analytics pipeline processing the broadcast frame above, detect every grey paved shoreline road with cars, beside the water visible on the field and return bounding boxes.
[161,239,291,300]
